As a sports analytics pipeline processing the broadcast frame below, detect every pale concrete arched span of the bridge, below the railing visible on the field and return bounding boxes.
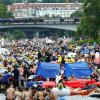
[0,23,78,31]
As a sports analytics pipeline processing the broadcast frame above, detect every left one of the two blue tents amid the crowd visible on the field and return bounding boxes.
[36,62,60,78]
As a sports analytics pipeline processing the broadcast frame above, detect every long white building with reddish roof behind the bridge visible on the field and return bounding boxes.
[8,3,82,18]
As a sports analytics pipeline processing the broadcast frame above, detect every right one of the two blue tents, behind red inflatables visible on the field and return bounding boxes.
[65,62,92,78]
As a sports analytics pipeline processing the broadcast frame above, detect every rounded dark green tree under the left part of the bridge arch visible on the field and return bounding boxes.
[12,30,26,40]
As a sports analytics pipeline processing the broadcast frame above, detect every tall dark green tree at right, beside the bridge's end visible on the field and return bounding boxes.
[77,0,100,39]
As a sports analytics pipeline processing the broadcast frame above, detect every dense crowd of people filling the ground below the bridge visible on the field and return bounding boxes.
[0,38,100,100]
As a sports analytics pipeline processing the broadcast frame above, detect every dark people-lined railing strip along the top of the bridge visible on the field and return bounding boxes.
[0,18,79,25]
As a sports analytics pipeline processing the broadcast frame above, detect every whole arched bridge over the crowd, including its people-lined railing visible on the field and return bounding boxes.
[0,19,79,31]
